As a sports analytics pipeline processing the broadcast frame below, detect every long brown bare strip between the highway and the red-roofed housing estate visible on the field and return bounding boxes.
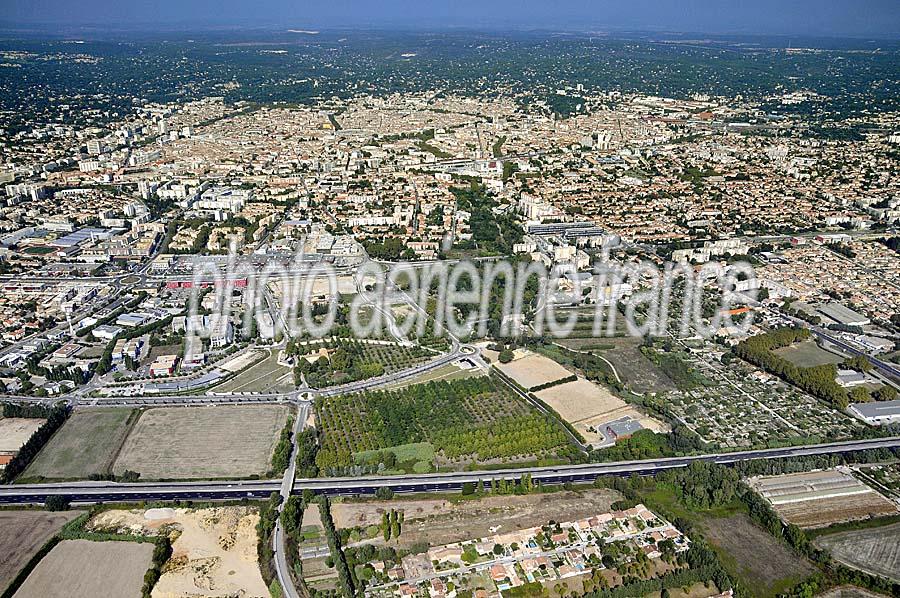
[332,489,620,546]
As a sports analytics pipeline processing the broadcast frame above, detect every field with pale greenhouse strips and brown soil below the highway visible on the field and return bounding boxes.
[748,468,898,528]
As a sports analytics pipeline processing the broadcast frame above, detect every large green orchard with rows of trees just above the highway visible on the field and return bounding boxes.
[316,377,570,471]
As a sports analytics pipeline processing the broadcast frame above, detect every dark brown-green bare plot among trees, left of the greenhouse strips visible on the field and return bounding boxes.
[703,514,815,596]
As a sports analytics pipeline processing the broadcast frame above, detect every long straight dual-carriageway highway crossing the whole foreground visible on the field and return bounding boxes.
[0,436,900,504]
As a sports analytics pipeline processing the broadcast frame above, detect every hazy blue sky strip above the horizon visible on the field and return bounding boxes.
[0,0,900,40]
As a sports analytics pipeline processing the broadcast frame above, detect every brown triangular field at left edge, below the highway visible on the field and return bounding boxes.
[0,511,81,592]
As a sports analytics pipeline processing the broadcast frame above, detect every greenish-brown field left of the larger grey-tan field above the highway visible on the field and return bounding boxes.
[21,408,140,480]
